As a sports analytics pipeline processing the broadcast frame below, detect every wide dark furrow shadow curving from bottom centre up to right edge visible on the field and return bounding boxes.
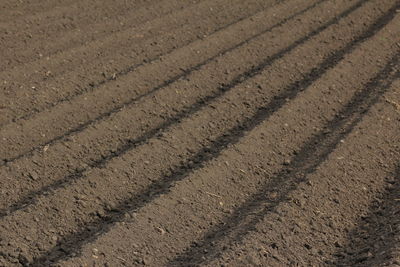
[167,55,400,266]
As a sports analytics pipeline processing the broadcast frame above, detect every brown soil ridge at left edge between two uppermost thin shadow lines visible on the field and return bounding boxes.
[0,0,322,161]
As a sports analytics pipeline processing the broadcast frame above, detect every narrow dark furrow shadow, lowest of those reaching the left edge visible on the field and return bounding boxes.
[0,0,366,218]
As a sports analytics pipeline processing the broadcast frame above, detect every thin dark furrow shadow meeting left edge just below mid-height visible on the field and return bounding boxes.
[0,0,326,166]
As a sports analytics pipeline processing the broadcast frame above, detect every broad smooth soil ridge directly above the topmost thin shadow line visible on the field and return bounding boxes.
[1,0,269,118]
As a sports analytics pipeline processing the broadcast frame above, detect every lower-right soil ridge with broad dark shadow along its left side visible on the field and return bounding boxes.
[177,60,400,266]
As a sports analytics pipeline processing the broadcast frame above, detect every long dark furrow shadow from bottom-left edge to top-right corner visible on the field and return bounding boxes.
[29,6,398,266]
